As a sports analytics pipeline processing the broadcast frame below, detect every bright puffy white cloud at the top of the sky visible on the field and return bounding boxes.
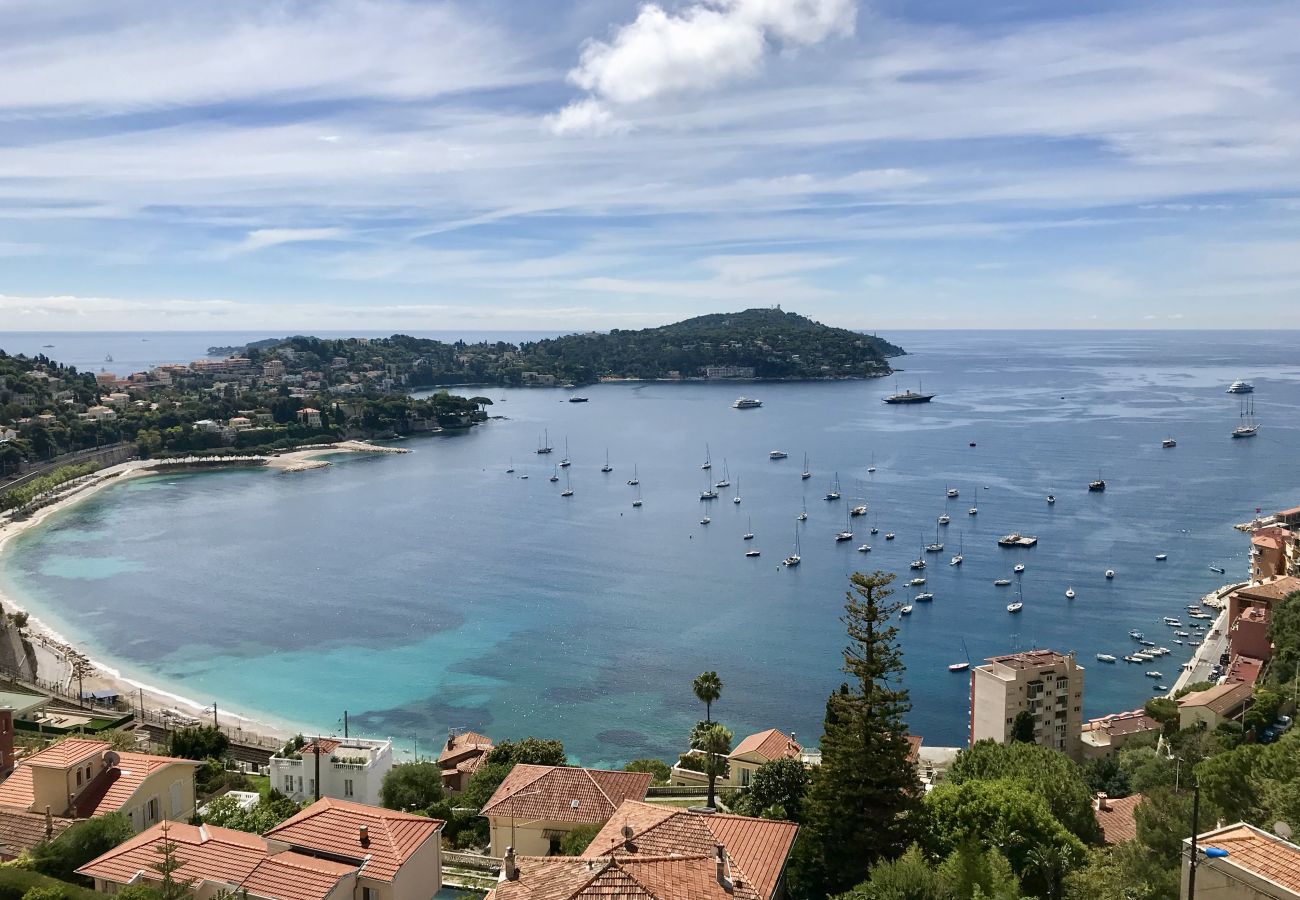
[569,0,855,104]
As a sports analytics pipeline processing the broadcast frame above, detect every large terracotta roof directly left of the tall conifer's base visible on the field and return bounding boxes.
[584,800,798,899]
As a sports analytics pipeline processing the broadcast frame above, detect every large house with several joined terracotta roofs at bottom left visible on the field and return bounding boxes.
[77,800,443,900]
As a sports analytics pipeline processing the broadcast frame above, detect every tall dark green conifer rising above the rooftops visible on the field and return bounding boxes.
[790,571,920,899]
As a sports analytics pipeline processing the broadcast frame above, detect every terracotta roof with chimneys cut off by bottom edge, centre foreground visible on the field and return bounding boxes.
[488,856,758,900]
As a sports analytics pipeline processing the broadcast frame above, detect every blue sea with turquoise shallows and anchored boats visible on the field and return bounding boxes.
[0,332,1300,766]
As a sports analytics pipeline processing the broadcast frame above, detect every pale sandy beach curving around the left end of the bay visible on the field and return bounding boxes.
[0,441,411,743]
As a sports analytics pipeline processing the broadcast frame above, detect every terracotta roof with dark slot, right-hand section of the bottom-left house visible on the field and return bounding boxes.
[267,797,443,882]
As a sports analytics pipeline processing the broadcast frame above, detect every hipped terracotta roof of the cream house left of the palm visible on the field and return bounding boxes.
[480,765,653,825]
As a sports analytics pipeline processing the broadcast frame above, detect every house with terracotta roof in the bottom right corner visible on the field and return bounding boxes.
[1179,822,1300,900]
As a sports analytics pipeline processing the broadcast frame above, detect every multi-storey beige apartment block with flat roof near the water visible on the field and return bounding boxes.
[970,650,1083,760]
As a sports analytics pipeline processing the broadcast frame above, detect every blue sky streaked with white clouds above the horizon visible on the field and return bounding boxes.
[0,0,1300,332]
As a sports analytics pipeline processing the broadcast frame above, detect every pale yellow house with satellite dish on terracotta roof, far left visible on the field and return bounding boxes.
[0,737,203,832]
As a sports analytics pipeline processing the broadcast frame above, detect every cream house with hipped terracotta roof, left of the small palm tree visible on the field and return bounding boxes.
[480,763,653,857]
